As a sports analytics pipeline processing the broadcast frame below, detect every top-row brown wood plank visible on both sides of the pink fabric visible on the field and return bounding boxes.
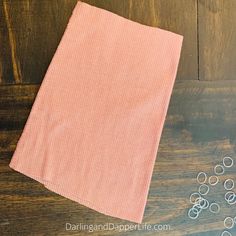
[0,0,197,84]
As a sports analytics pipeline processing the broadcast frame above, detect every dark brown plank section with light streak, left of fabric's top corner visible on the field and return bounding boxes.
[0,0,77,84]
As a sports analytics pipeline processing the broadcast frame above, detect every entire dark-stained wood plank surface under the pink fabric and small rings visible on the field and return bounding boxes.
[0,0,236,236]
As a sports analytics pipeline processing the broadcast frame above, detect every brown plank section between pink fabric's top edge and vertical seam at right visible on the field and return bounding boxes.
[83,0,198,80]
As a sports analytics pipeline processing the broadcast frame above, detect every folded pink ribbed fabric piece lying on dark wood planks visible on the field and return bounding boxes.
[9,2,183,223]
